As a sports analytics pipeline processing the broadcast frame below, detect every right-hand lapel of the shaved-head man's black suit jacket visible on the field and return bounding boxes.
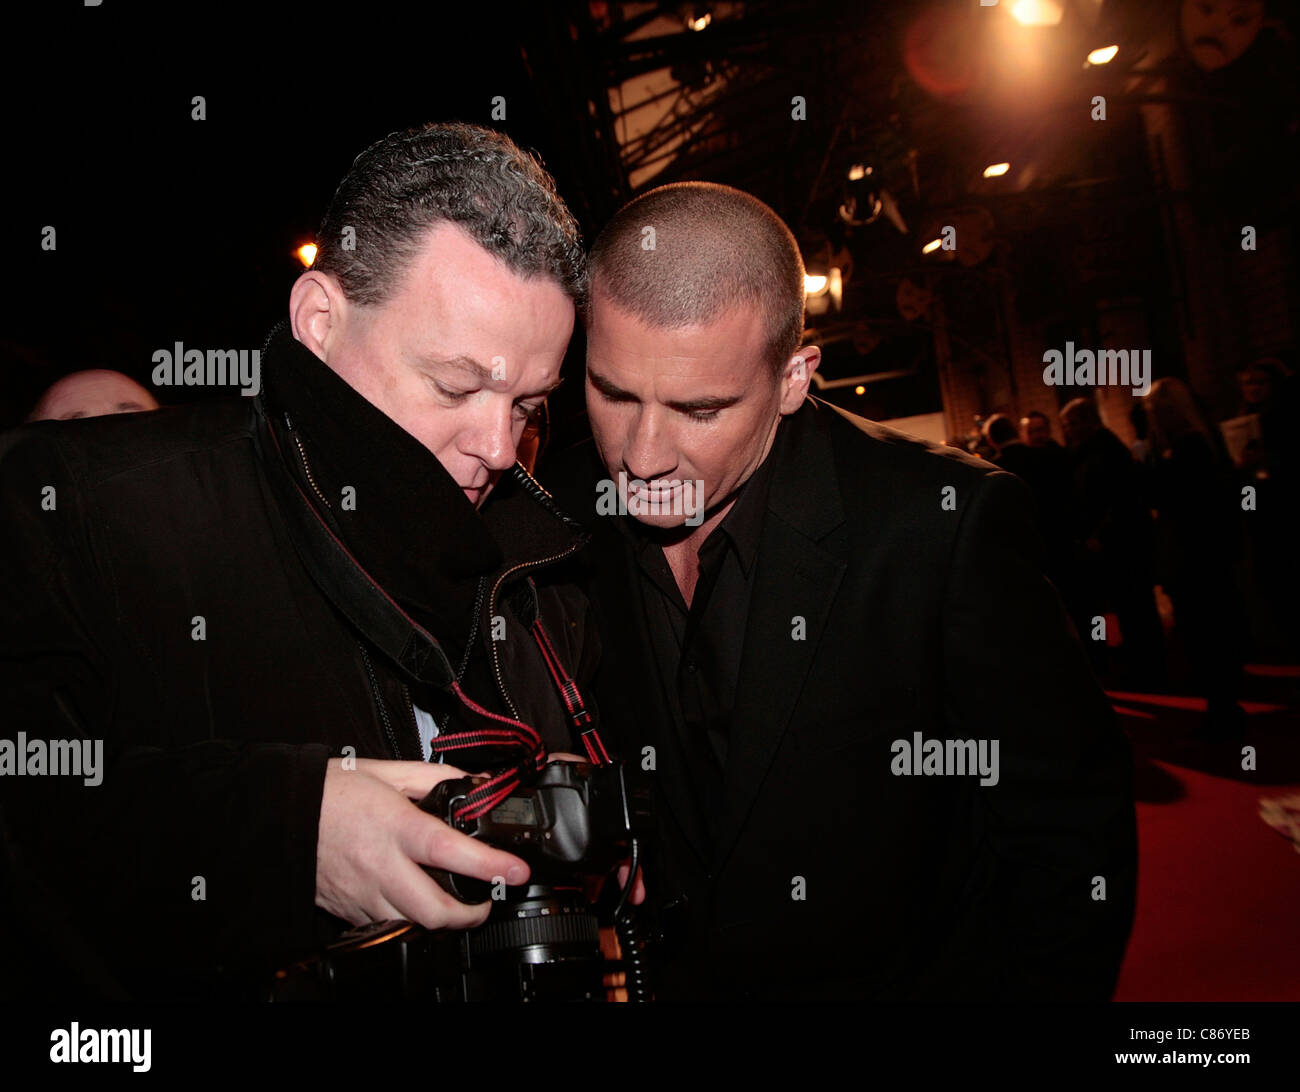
[714,400,848,868]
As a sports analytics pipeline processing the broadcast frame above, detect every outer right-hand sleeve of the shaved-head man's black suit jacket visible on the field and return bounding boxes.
[943,473,1136,1000]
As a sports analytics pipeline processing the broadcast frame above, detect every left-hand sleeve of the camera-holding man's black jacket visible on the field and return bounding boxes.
[0,438,329,983]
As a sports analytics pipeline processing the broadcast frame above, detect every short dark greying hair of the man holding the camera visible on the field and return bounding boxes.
[312,122,586,308]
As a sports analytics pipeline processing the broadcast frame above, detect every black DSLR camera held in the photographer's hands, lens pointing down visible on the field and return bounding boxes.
[270,761,650,1002]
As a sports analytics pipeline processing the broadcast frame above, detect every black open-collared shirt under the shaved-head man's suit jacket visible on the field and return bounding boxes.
[619,439,780,842]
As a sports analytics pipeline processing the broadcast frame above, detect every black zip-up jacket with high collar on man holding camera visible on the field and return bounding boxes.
[0,328,599,998]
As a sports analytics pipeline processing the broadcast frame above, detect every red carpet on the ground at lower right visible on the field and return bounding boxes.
[1112,668,1300,1001]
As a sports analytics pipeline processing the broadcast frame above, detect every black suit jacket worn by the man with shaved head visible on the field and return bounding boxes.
[547,399,1136,1001]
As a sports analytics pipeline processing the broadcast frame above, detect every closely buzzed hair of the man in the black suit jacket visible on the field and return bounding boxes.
[584,182,803,376]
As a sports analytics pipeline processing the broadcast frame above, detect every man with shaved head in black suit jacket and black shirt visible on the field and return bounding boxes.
[549,182,1135,1001]
